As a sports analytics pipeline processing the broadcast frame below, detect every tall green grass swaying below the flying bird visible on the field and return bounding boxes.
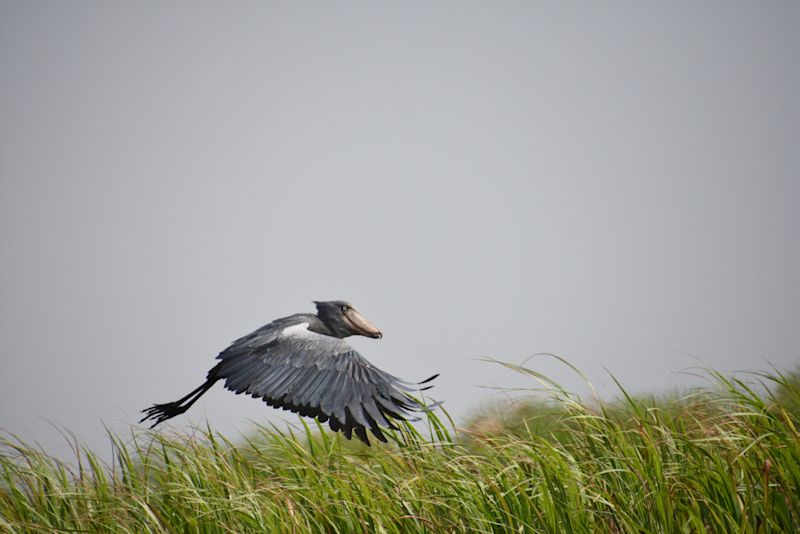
[0,364,800,534]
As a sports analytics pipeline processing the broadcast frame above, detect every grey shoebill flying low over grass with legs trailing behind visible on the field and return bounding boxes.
[139,300,439,445]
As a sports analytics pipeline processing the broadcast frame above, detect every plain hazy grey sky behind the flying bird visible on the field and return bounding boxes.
[0,1,800,460]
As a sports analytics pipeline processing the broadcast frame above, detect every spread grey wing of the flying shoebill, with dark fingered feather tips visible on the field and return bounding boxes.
[212,322,435,445]
